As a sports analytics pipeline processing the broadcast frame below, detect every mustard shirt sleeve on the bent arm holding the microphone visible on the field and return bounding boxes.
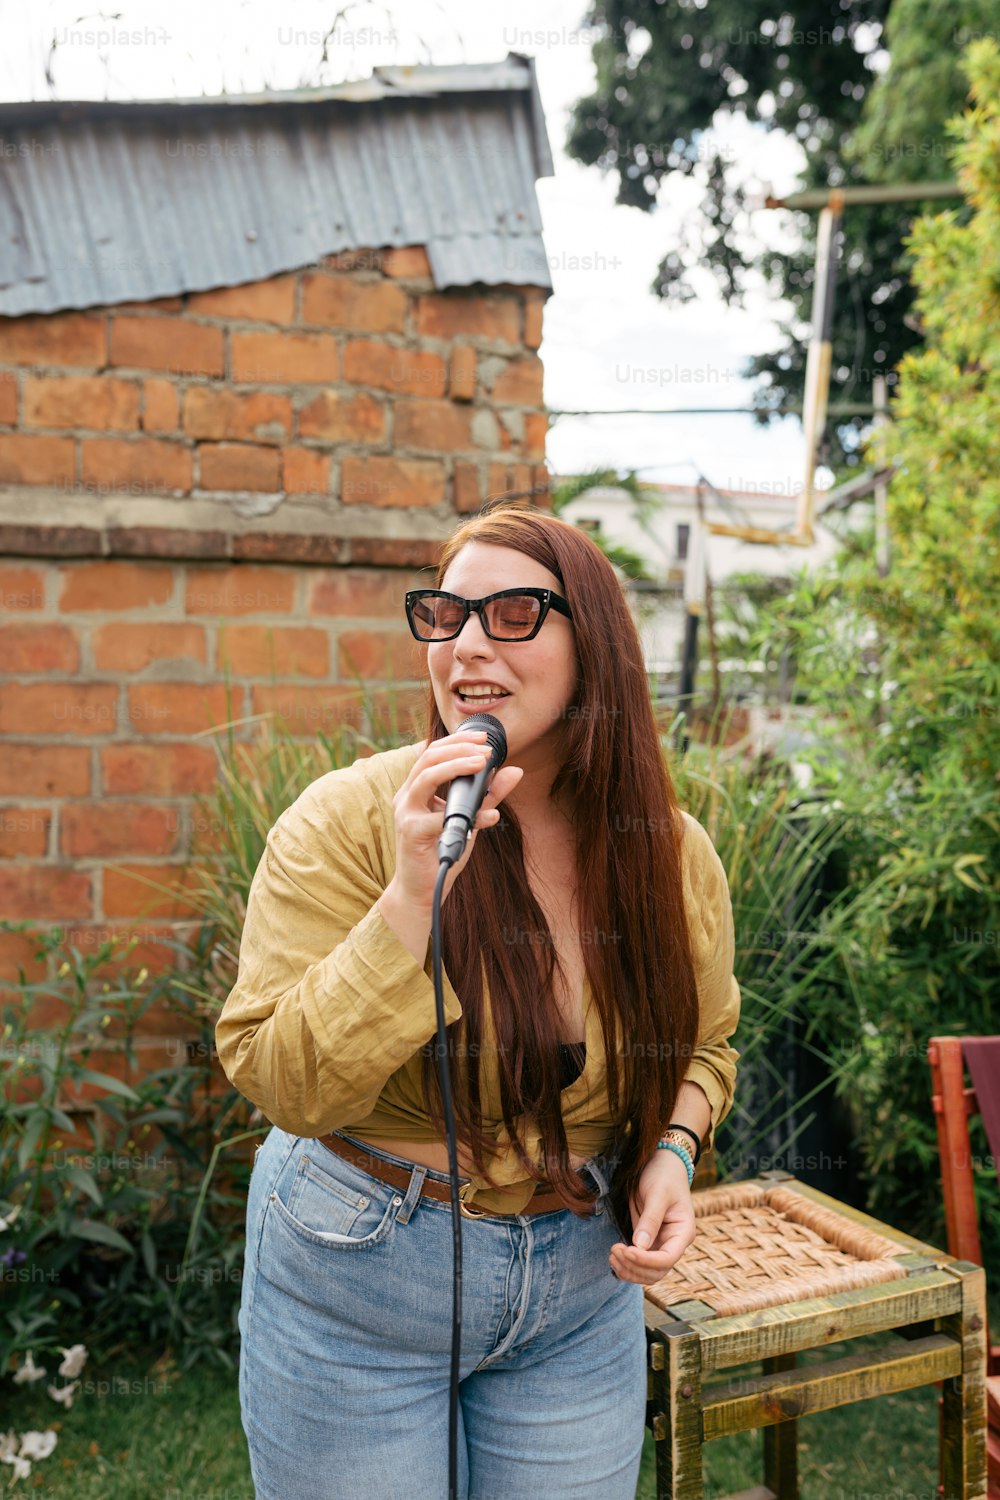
[216,768,462,1137]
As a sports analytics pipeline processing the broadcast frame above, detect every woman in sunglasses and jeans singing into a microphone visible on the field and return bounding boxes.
[217,509,739,1500]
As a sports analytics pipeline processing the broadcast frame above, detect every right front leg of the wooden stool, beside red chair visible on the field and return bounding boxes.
[940,1260,987,1500]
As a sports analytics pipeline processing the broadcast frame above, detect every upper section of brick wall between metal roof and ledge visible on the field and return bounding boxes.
[0,246,546,512]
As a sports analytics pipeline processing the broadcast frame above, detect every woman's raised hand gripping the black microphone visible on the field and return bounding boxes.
[378,729,525,965]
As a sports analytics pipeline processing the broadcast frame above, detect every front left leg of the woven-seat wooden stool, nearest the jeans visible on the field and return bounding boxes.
[652,1323,705,1500]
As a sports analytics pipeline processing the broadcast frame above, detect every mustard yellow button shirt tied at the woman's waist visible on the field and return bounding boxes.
[216,744,739,1214]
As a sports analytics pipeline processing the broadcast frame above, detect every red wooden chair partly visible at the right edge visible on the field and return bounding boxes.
[927,1037,1000,1500]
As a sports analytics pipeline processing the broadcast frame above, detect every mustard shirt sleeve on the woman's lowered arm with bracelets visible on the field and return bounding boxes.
[681,813,741,1149]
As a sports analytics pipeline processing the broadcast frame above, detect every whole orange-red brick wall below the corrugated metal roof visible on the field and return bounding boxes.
[0,248,547,1134]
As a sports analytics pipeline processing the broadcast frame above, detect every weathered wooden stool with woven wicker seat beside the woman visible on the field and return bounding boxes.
[645,1172,987,1500]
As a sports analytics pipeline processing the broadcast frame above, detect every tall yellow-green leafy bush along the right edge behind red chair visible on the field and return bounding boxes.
[728,39,1000,1265]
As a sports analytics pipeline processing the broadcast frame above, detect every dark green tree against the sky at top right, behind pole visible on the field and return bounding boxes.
[567,0,997,467]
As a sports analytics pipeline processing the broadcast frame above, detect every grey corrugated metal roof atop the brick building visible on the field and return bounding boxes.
[0,53,553,317]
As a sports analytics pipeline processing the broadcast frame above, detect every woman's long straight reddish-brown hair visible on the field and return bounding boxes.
[421,503,699,1244]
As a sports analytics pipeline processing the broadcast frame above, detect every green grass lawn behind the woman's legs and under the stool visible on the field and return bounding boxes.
[0,1298,1000,1500]
